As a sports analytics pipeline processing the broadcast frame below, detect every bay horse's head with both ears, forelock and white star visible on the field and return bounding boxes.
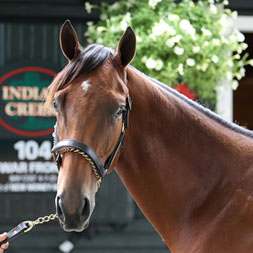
[46,21,136,231]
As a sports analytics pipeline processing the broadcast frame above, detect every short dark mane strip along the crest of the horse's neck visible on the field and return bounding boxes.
[131,66,253,138]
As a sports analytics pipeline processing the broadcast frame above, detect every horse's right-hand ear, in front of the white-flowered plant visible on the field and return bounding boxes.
[115,26,136,67]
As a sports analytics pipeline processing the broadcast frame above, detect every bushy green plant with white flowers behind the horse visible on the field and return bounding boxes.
[85,0,253,101]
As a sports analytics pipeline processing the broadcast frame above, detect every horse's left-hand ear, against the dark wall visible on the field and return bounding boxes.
[60,20,81,61]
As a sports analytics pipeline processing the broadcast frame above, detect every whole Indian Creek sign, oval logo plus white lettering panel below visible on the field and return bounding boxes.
[0,66,58,192]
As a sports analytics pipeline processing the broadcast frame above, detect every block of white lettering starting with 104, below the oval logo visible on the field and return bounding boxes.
[0,140,58,192]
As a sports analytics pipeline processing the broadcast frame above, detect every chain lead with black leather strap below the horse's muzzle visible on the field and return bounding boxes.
[0,214,58,246]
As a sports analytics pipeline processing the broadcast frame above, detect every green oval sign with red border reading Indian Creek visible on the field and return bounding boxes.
[0,67,56,137]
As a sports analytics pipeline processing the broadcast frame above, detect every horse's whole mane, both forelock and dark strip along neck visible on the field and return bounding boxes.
[45,44,253,138]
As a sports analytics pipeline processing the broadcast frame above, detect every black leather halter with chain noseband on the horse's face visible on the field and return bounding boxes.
[51,88,132,185]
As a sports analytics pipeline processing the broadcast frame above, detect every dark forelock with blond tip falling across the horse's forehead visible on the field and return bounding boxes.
[45,44,113,107]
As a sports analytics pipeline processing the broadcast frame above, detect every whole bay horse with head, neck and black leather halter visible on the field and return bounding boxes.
[46,21,253,253]
